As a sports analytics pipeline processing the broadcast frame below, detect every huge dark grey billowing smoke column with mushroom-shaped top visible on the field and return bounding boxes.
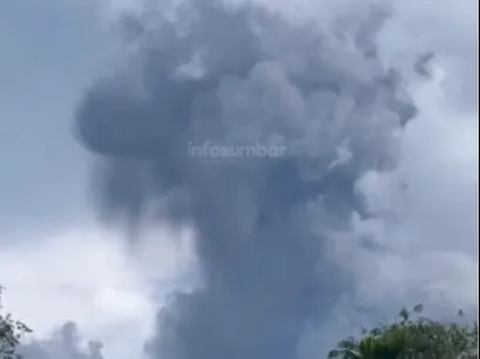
[77,0,415,359]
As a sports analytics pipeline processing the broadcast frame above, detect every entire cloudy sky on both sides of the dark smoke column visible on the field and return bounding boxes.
[0,0,478,359]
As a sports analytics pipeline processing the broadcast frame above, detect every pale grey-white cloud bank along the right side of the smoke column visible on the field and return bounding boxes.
[314,1,479,347]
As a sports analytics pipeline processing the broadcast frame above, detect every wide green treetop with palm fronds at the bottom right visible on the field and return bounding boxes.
[328,304,478,359]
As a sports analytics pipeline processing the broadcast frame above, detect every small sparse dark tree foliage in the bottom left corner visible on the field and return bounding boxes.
[0,286,31,359]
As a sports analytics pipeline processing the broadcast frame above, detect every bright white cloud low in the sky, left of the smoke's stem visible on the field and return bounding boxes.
[0,226,195,359]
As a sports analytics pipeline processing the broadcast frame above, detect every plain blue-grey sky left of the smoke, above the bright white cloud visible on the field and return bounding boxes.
[0,1,102,236]
